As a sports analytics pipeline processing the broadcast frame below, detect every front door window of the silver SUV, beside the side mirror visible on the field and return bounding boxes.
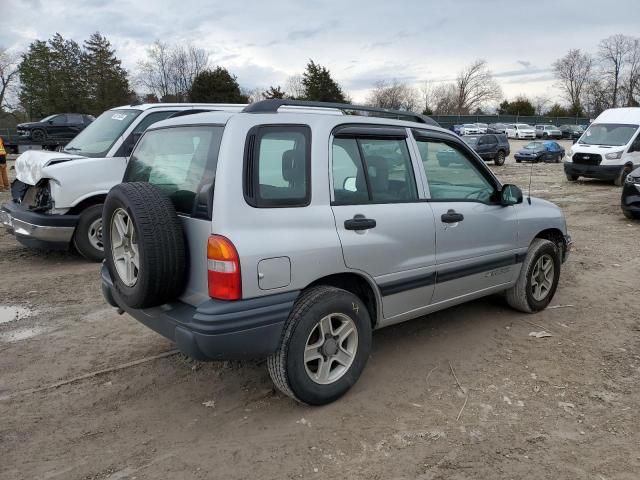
[417,139,496,203]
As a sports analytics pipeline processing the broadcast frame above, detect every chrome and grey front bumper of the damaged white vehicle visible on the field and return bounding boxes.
[0,202,80,249]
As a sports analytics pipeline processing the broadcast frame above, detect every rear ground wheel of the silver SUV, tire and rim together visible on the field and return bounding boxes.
[267,286,371,405]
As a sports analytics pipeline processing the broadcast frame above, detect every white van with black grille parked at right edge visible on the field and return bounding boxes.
[564,107,640,186]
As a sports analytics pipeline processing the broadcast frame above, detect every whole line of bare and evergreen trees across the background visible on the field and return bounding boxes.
[0,32,640,122]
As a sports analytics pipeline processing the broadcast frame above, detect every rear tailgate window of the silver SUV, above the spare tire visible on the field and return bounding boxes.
[124,125,224,218]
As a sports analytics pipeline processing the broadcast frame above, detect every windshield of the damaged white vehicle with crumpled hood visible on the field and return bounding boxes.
[64,110,142,158]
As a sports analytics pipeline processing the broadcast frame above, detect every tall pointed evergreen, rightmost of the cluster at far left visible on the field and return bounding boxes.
[83,32,132,115]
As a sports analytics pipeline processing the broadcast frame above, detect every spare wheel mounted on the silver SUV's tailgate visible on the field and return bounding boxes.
[102,182,186,308]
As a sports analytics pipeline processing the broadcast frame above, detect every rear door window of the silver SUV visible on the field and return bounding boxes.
[332,138,418,205]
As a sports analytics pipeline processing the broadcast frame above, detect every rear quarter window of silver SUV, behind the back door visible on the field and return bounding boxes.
[244,125,311,208]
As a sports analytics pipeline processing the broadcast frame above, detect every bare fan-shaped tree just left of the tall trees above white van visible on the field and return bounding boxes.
[553,49,593,113]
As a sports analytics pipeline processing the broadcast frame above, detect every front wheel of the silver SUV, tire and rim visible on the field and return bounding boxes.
[507,238,561,313]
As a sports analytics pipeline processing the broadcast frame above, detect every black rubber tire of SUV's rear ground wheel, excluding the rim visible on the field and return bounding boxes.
[267,286,372,405]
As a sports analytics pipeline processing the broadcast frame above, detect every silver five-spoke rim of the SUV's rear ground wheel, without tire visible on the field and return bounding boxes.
[304,313,358,385]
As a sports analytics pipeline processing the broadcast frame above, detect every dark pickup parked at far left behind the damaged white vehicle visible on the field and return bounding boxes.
[16,113,95,143]
